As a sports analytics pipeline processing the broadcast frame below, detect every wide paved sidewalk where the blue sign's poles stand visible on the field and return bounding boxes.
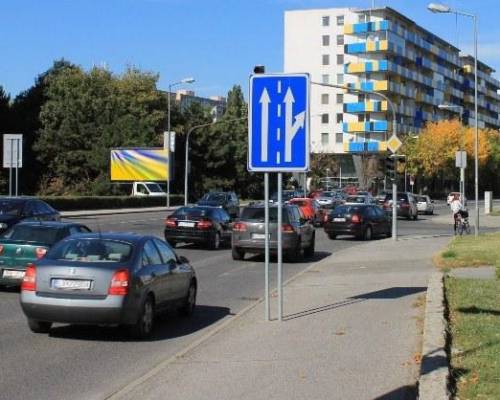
[112,238,449,400]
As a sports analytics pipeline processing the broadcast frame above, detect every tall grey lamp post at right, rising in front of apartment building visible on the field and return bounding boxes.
[427,3,479,237]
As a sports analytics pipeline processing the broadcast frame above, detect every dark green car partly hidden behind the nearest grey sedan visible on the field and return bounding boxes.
[0,221,90,286]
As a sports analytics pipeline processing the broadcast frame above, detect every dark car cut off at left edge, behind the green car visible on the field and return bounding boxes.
[0,197,61,233]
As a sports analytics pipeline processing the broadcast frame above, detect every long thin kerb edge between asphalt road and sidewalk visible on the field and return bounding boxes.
[104,245,333,400]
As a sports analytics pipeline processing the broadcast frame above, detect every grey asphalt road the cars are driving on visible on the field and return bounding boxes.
[0,205,451,400]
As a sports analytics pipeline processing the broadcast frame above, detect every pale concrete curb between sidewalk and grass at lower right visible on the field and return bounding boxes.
[418,271,450,400]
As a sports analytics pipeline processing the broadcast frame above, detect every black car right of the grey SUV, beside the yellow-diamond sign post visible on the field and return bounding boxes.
[323,204,392,240]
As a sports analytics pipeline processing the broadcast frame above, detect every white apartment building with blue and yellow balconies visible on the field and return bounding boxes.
[284,7,500,159]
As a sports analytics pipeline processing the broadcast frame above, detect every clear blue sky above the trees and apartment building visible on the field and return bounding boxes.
[0,0,500,97]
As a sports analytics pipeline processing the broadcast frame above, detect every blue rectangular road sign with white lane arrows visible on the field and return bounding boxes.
[248,74,309,172]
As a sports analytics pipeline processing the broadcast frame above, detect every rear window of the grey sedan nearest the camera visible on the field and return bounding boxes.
[45,238,133,263]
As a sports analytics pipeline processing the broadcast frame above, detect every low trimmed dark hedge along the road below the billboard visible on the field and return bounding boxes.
[39,194,184,211]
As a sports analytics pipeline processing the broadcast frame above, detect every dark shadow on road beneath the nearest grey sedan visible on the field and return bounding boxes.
[50,305,233,342]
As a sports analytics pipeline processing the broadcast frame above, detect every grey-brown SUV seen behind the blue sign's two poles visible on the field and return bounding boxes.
[231,204,316,261]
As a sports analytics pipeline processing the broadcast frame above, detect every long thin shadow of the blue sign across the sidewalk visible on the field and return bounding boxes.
[283,286,427,321]
